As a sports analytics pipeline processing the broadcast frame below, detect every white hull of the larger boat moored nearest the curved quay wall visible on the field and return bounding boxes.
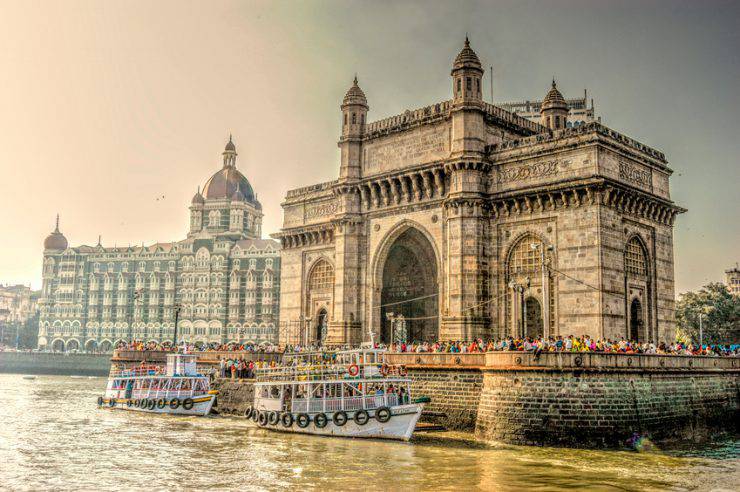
[255,403,424,441]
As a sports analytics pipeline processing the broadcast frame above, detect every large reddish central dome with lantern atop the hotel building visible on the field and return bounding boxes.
[189,135,262,239]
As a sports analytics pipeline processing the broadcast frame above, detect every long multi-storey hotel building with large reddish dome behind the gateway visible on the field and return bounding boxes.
[38,138,280,352]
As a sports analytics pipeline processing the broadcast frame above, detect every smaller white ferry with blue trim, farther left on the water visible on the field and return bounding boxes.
[98,354,218,416]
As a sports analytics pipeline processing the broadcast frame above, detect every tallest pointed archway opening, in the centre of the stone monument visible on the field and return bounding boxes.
[380,228,439,343]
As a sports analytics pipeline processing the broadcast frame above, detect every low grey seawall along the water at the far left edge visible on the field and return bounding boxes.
[0,352,110,376]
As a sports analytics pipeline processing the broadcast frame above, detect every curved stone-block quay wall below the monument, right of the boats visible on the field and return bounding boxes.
[389,352,740,447]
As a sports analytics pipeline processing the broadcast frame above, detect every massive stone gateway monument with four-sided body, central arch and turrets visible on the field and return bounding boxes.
[273,39,685,345]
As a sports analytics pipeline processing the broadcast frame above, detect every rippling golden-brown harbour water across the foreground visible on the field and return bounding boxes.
[0,374,740,490]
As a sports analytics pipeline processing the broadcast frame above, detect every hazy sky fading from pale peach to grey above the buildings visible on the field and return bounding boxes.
[0,0,740,292]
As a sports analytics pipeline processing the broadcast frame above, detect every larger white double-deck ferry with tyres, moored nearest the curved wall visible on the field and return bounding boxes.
[245,349,429,441]
